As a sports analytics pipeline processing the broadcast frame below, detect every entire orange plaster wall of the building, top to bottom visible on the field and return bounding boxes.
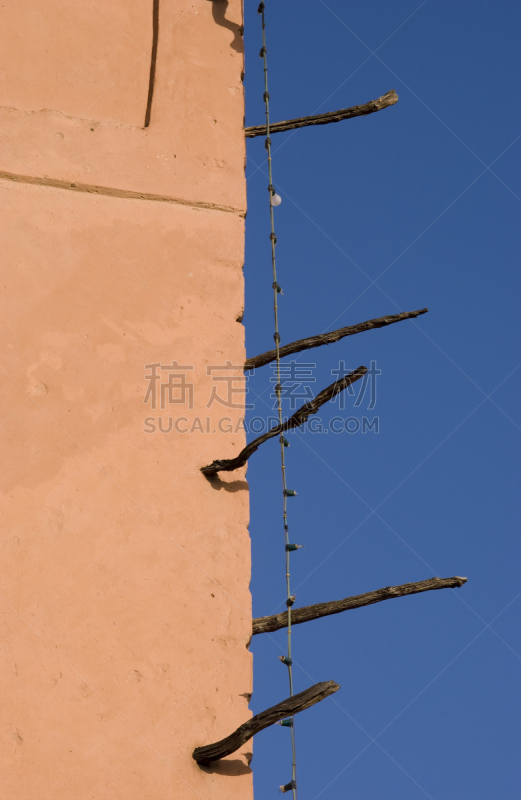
[0,0,252,800]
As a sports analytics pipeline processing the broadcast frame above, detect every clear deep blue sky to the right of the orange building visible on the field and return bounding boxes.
[244,0,521,800]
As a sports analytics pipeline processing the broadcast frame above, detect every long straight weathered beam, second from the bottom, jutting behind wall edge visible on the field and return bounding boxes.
[253,575,467,636]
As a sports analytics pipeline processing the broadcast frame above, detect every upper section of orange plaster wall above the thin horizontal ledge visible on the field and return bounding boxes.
[0,0,246,213]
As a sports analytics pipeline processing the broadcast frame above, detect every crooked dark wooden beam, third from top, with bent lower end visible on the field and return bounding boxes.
[201,367,367,477]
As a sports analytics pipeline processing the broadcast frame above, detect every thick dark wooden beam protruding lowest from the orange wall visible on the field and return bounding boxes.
[192,681,340,766]
